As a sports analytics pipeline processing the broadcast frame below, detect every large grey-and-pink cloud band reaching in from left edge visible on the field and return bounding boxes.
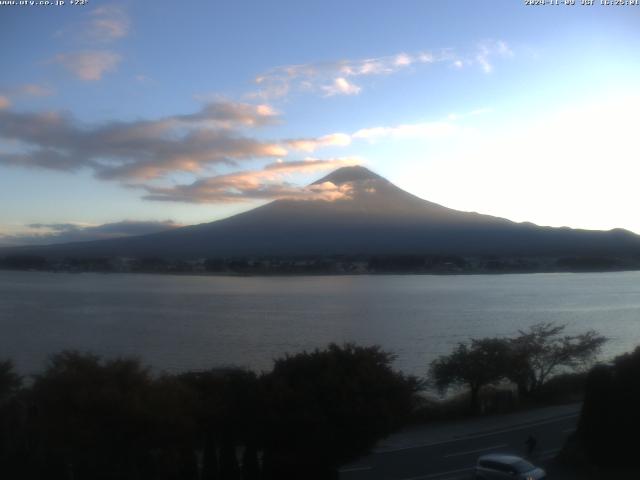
[0,102,287,180]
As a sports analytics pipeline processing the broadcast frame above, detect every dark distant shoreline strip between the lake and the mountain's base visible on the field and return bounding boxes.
[0,254,640,275]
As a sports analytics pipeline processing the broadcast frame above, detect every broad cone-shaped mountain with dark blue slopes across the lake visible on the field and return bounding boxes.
[5,167,640,258]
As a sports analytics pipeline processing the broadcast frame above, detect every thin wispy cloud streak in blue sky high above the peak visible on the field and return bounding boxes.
[254,40,513,98]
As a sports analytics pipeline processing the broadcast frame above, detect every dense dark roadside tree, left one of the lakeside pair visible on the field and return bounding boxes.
[429,338,510,412]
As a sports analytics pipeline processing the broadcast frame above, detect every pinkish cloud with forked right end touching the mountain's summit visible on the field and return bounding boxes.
[142,158,360,203]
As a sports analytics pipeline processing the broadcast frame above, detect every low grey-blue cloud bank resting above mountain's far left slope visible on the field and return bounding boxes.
[0,220,182,246]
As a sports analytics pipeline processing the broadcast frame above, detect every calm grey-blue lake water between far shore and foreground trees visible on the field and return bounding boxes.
[0,271,640,375]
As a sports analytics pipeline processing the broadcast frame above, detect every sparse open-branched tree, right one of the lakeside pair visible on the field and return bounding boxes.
[505,322,607,397]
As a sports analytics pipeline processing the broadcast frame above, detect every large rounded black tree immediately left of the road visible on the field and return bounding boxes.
[262,344,418,480]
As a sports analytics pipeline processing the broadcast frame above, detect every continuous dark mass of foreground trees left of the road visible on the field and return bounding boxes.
[0,344,419,480]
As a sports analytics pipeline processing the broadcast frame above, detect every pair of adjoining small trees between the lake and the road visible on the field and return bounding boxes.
[429,322,606,412]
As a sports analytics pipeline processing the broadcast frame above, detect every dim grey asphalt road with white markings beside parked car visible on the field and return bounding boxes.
[340,413,578,480]
